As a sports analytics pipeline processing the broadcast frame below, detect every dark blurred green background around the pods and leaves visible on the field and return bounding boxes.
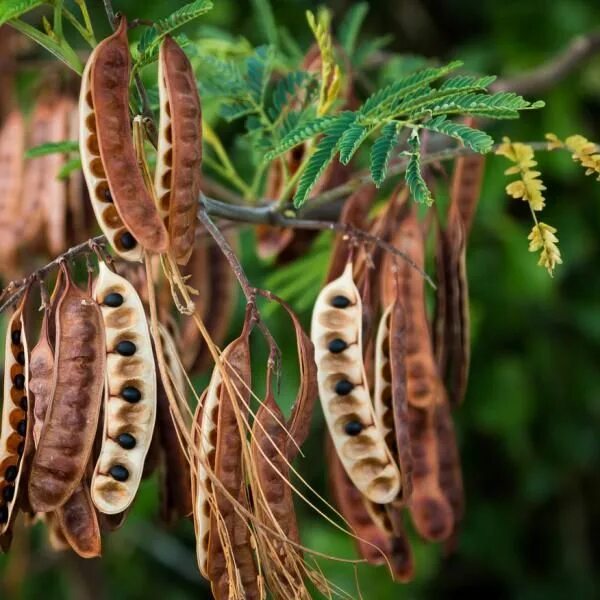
[0,0,600,600]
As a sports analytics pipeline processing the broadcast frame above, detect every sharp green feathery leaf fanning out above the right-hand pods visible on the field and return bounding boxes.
[266,56,543,206]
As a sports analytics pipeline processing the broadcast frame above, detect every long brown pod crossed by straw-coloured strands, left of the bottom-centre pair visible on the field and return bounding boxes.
[205,319,260,600]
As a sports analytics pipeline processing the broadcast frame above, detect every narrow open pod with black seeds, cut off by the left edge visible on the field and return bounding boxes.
[0,293,31,536]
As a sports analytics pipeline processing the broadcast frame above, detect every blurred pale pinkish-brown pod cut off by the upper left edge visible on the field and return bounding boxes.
[0,110,25,276]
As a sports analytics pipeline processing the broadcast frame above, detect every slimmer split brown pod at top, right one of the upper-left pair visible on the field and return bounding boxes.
[155,36,202,265]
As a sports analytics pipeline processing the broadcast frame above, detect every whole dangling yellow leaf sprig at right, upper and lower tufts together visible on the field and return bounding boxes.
[496,137,562,277]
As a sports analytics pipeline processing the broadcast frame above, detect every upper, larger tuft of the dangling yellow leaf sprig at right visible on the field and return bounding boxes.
[496,137,546,210]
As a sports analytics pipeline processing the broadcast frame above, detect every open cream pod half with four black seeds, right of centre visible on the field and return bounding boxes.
[311,263,401,504]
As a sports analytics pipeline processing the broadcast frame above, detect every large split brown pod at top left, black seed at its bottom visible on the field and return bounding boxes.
[79,18,169,260]
